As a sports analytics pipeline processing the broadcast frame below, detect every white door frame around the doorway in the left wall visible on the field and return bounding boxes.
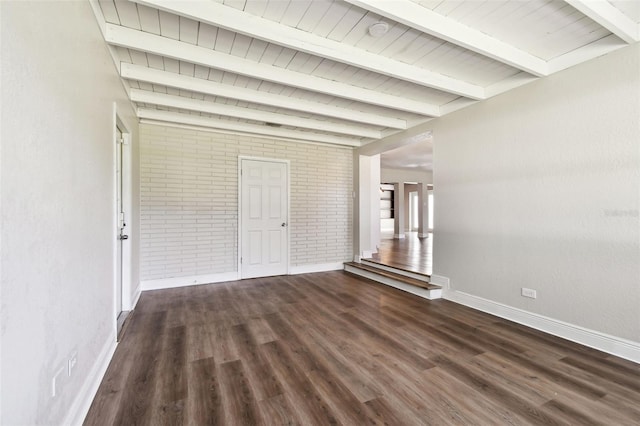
[111,102,133,338]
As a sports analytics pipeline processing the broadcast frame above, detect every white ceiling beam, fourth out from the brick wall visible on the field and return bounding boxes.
[105,24,440,117]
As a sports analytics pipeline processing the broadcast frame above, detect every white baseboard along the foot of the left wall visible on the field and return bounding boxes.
[62,334,118,426]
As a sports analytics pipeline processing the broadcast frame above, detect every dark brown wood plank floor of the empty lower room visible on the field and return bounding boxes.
[85,271,640,425]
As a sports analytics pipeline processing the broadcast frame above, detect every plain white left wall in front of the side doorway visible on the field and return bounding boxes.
[0,1,136,425]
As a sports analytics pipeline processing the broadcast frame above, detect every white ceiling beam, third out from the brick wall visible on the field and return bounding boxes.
[120,62,407,130]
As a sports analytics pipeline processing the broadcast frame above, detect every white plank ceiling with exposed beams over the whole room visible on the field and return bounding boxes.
[92,0,640,147]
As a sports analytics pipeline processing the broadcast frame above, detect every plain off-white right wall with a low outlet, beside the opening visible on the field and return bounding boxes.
[430,44,640,342]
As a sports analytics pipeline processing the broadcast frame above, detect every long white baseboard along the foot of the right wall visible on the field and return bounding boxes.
[443,290,640,363]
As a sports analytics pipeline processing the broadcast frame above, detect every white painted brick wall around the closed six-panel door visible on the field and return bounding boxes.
[140,124,353,281]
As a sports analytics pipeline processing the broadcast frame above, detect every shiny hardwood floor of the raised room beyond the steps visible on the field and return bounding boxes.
[372,232,433,275]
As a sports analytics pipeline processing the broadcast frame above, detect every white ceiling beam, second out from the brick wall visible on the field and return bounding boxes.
[129,89,381,139]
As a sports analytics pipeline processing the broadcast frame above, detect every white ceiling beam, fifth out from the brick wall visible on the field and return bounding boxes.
[133,0,484,99]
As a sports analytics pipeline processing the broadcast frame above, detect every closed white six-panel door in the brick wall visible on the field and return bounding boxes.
[240,159,289,278]
